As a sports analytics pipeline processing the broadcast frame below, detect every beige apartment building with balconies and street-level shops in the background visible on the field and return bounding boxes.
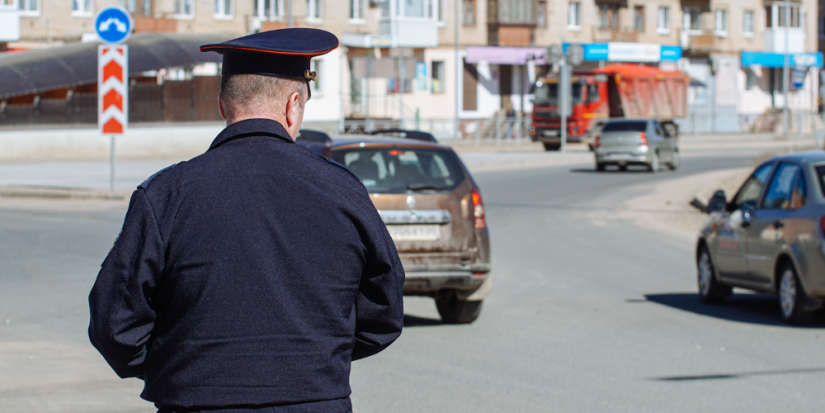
[7,0,825,131]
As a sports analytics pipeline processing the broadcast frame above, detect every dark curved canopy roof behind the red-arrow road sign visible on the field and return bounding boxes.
[0,33,226,98]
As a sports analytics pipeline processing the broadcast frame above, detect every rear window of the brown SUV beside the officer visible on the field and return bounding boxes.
[332,148,464,194]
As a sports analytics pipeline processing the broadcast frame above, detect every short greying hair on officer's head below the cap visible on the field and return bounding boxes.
[221,75,306,118]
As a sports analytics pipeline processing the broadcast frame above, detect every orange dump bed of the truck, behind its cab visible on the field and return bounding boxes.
[592,64,690,120]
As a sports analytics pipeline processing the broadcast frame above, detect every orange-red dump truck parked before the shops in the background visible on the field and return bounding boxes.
[530,64,690,151]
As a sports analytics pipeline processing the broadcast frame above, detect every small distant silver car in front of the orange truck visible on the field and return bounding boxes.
[593,119,679,173]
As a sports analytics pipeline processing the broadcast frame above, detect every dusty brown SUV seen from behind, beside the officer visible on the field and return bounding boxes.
[329,136,491,323]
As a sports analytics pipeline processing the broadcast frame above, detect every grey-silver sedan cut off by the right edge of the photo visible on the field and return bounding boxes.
[696,152,825,324]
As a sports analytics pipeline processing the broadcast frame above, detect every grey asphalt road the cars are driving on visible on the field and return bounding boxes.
[0,150,825,412]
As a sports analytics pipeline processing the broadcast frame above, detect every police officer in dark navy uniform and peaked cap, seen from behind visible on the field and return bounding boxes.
[89,28,404,413]
